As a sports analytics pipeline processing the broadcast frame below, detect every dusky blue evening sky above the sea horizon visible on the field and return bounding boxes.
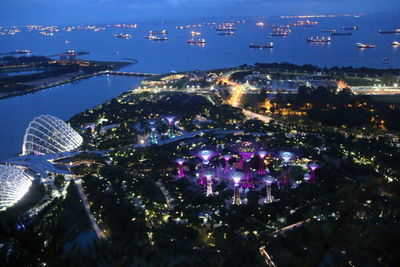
[0,0,400,25]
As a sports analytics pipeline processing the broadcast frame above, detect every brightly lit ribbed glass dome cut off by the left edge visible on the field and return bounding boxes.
[0,165,32,210]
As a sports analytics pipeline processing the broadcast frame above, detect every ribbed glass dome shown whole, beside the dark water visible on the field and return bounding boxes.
[22,115,83,155]
